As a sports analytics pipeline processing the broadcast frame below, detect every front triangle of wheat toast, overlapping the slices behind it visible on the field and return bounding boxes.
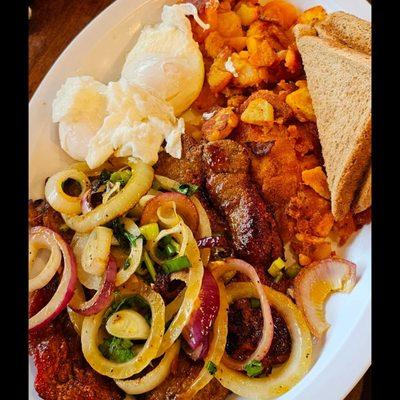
[293,25,371,220]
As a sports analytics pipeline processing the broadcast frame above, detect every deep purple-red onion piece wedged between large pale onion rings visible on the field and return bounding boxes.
[182,268,219,360]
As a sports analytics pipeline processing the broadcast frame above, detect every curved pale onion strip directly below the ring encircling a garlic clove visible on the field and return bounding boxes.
[115,340,180,394]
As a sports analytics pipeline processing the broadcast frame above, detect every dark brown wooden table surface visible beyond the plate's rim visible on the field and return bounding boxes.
[29,0,371,400]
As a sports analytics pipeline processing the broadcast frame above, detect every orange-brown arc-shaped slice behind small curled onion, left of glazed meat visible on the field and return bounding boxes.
[140,192,199,233]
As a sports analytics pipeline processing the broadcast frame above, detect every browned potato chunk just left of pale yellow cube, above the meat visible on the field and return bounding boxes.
[201,107,239,142]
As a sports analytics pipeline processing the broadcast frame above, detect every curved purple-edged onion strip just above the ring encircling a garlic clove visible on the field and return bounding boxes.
[70,256,117,316]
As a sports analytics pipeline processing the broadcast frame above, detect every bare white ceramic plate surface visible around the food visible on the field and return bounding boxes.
[29,0,371,400]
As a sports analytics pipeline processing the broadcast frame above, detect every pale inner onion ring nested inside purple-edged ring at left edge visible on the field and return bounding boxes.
[29,230,61,292]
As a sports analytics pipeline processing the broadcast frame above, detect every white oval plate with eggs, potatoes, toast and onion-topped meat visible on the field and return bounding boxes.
[29,0,371,400]
